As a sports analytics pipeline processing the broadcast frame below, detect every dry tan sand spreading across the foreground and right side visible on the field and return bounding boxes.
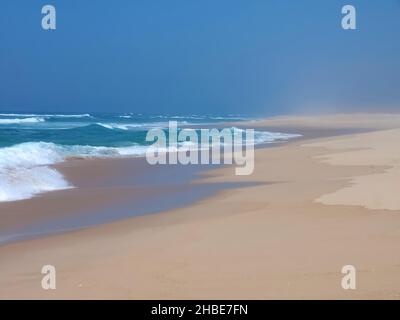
[0,114,400,299]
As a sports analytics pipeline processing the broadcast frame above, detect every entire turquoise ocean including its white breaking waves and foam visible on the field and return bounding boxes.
[0,112,298,202]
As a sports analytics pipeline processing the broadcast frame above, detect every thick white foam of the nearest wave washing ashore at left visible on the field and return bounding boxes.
[0,142,145,201]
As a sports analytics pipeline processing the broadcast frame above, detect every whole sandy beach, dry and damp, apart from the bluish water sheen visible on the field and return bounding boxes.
[0,114,400,299]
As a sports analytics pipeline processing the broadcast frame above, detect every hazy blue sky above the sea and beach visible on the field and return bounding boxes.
[0,0,400,115]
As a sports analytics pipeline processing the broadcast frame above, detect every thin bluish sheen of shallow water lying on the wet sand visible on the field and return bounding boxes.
[0,159,256,245]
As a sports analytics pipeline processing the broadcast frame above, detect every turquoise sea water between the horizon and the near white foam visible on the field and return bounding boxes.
[0,113,256,147]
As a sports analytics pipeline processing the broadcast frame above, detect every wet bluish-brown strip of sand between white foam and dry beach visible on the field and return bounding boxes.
[0,122,302,246]
